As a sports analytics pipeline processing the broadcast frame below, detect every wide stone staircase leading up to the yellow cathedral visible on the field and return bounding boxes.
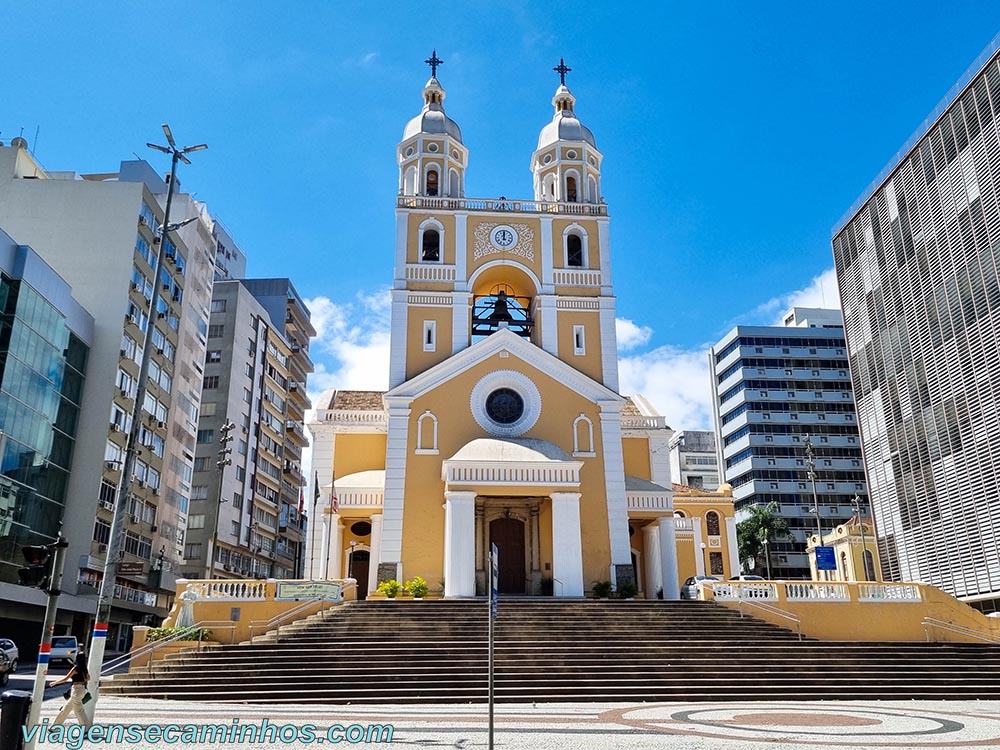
[102,598,1000,703]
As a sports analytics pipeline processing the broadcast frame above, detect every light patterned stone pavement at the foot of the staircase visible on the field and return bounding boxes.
[29,697,1000,750]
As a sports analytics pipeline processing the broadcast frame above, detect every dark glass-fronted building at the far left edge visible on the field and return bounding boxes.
[0,230,94,648]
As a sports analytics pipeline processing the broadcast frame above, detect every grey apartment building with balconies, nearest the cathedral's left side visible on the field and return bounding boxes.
[184,279,315,578]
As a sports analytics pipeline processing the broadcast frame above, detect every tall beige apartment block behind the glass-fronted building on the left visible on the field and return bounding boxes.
[0,144,215,649]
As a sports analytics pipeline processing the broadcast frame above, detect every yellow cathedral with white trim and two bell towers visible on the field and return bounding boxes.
[308,54,738,599]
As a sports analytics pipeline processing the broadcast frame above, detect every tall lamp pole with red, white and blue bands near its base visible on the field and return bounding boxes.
[84,124,208,721]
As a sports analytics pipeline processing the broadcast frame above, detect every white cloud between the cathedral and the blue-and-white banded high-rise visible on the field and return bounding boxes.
[618,346,712,430]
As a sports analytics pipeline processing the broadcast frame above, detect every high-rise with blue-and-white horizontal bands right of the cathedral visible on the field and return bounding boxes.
[709,308,866,579]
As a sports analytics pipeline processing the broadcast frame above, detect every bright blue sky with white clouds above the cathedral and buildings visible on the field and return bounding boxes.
[0,0,1000,428]
